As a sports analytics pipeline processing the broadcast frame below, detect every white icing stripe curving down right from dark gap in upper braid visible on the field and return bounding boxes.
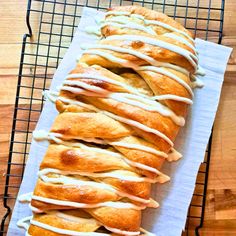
[138,66,194,97]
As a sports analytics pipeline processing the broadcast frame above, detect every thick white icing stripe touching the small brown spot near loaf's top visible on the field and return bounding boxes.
[103,35,198,70]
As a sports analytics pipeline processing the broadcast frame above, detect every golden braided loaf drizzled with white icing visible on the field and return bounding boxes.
[18,6,198,236]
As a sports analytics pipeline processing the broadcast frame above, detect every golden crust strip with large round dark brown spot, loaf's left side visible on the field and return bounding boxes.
[40,144,133,173]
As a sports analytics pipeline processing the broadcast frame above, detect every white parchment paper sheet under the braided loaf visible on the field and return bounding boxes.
[8,8,232,236]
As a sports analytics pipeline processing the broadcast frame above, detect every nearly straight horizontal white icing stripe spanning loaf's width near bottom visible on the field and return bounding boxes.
[32,195,146,210]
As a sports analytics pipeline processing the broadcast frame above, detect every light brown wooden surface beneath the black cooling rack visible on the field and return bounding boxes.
[0,0,236,235]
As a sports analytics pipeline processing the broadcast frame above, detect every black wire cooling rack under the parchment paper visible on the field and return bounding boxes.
[0,0,224,235]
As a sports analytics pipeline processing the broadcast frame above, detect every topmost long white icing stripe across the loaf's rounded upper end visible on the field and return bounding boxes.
[106,11,194,42]
